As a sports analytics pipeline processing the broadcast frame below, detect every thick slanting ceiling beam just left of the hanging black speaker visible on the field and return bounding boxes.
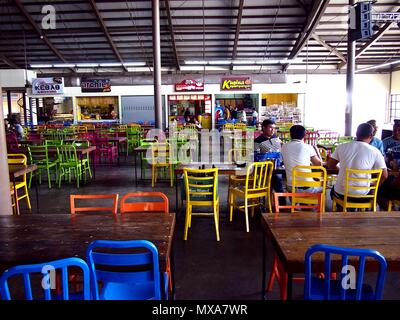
[282,0,329,72]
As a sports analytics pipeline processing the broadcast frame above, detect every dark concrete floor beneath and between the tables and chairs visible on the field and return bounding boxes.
[16,157,400,300]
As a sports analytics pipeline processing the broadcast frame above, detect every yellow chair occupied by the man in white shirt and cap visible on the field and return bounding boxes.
[332,168,382,212]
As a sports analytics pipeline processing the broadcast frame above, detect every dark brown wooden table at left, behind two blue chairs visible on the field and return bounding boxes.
[0,213,175,297]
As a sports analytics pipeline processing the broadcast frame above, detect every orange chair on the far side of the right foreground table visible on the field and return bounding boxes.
[267,192,322,300]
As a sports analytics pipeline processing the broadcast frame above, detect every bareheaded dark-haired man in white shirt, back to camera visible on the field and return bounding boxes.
[282,125,322,192]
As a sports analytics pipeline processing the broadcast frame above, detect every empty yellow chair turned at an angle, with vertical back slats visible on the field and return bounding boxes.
[229,161,274,232]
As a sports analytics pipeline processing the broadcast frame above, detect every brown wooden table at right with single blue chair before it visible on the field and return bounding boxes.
[261,212,400,299]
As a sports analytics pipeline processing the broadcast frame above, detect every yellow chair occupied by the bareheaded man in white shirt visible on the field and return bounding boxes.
[292,166,327,212]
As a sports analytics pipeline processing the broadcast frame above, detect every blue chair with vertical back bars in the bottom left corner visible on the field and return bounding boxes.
[0,258,90,300]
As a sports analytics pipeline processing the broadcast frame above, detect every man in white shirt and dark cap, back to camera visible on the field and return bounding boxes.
[327,123,388,205]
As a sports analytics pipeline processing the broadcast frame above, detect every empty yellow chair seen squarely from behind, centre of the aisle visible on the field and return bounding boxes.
[183,168,220,241]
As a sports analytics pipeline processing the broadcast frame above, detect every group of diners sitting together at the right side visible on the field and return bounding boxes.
[254,119,400,210]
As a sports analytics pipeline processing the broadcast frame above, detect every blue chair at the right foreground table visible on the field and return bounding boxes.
[304,244,387,300]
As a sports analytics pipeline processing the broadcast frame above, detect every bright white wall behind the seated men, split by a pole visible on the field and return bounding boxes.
[305,74,390,136]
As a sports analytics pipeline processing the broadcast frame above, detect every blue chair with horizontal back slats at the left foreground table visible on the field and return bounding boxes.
[86,240,168,300]
